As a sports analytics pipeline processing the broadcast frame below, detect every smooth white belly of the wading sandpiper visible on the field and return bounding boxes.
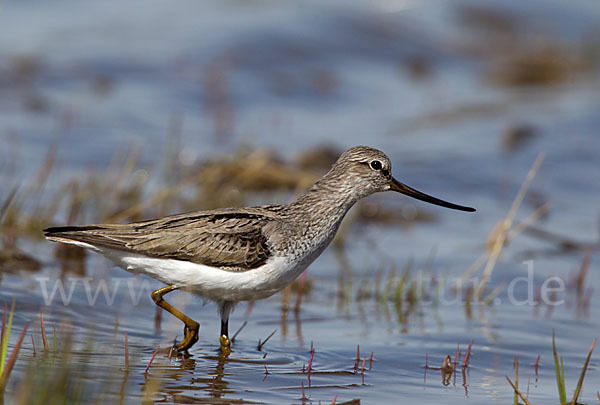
[104,251,307,301]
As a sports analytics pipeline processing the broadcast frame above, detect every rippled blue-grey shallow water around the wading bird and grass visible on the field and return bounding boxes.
[0,1,600,404]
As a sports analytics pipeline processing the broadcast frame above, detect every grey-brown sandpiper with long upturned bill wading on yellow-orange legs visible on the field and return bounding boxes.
[44,146,475,354]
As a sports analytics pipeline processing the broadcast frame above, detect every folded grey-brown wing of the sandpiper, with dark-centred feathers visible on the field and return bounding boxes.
[44,209,277,271]
